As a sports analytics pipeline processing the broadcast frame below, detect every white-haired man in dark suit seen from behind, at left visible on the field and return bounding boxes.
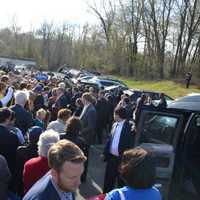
[10,91,33,135]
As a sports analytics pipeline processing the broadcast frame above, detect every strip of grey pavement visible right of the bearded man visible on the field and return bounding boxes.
[77,145,105,200]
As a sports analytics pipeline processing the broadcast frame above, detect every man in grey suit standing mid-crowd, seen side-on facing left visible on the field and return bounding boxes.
[80,92,96,145]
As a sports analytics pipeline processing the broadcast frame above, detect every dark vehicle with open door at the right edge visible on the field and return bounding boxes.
[135,101,200,200]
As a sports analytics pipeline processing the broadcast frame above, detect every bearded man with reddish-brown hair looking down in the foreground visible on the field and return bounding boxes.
[23,140,86,200]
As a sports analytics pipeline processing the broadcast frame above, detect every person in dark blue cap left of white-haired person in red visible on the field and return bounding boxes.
[16,126,43,196]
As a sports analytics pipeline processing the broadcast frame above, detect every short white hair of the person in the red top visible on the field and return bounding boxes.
[37,129,60,157]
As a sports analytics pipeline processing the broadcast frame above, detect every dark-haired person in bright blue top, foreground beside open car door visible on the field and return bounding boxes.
[106,147,161,200]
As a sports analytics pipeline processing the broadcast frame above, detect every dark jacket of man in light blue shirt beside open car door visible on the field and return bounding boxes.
[104,120,134,160]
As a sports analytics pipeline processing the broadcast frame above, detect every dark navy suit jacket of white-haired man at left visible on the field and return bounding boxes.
[10,104,33,135]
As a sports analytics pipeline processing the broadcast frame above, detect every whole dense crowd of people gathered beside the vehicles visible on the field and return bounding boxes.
[0,69,166,200]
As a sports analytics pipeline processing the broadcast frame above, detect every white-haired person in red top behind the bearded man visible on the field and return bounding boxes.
[23,130,60,194]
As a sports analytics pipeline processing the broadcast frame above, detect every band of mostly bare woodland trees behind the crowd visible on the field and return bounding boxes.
[0,0,200,83]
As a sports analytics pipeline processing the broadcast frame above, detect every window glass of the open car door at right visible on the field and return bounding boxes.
[140,113,178,144]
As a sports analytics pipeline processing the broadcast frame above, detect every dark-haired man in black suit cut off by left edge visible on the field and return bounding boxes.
[0,108,19,189]
